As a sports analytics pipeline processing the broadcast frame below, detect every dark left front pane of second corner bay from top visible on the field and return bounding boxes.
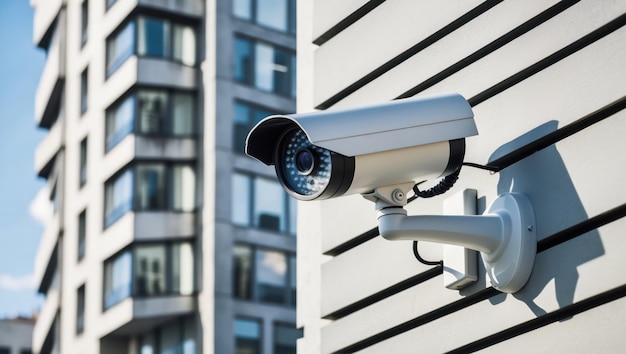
[137,90,167,134]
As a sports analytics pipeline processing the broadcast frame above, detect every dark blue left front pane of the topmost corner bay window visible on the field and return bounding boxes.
[137,16,169,58]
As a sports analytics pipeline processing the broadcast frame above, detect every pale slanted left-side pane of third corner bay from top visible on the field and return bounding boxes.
[105,169,133,226]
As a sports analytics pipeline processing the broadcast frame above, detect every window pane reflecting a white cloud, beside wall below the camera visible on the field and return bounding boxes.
[255,250,287,304]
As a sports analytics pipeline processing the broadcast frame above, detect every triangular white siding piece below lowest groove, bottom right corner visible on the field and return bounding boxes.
[481,298,626,353]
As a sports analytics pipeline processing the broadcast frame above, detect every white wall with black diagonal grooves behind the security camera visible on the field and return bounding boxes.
[298,0,626,354]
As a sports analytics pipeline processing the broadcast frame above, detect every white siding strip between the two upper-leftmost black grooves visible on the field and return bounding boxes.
[314,0,481,105]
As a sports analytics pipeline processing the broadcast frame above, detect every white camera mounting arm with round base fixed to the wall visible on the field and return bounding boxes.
[363,188,537,293]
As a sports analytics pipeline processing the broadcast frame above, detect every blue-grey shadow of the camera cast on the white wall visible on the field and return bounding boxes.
[489,121,605,317]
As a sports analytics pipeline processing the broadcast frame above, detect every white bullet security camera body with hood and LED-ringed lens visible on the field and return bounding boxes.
[246,94,478,200]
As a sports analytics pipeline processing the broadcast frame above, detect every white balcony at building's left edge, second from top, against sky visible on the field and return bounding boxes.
[35,10,66,128]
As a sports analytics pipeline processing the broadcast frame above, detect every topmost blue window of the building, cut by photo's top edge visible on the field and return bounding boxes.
[233,0,296,34]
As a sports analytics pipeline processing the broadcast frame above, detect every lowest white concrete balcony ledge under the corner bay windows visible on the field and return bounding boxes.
[98,295,196,338]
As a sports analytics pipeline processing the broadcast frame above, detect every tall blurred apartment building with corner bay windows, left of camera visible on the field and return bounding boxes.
[31,0,300,354]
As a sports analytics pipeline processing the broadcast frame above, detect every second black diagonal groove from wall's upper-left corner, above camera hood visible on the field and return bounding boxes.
[315,0,503,109]
